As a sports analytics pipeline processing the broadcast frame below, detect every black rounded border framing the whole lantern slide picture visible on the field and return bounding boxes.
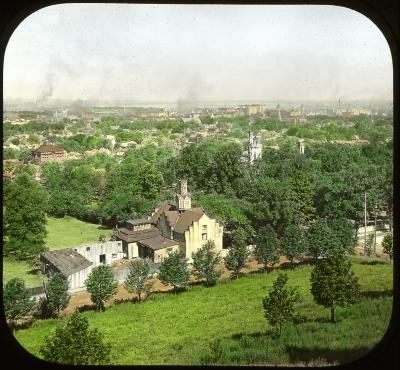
[0,0,400,370]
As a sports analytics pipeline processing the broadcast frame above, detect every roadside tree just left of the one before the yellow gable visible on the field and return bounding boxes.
[158,252,189,292]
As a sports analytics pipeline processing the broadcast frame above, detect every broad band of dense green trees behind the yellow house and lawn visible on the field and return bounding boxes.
[1,124,393,264]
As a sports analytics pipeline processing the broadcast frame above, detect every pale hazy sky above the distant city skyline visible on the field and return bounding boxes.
[4,4,392,102]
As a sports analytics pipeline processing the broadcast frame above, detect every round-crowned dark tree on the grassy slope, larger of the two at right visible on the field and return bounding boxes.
[310,255,360,323]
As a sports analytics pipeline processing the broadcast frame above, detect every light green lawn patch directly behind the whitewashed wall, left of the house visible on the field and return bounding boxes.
[46,216,111,250]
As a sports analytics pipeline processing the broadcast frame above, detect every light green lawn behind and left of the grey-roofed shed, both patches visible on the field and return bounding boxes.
[3,217,111,287]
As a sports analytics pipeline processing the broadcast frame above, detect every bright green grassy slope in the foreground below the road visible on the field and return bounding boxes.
[15,260,393,365]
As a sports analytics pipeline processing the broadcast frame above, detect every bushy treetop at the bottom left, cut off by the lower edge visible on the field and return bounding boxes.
[39,312,111,365]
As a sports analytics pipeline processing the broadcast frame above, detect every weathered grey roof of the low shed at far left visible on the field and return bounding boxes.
[41,248,92,276]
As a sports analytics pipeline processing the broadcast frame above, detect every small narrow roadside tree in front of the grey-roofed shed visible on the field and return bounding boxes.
[45,273,70,316]
